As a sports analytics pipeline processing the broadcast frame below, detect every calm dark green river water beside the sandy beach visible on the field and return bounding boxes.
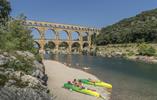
[44,55,157,100]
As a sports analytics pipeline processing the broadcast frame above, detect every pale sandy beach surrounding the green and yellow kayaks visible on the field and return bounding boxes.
[43,60,110,100]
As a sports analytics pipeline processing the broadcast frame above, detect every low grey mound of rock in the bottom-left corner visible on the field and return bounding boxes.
[0,87,52,100]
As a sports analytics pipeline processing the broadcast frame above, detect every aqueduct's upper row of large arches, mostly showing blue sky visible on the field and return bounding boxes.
[30,27,90,41]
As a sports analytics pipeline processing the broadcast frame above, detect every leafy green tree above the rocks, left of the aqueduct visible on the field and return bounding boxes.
[0,16,34,52]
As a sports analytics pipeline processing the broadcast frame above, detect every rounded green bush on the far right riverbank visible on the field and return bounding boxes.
[138,43,156,56]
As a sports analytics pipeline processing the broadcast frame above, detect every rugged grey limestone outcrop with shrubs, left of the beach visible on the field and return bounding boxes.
[0,51,52,100]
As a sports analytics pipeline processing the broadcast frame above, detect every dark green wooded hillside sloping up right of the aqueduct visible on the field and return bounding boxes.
[96,9,157,45]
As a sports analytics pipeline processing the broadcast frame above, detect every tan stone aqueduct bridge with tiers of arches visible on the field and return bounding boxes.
[24,20,100,53]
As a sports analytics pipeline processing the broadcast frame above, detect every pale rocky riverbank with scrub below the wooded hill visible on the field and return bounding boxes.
[97,44,157,63]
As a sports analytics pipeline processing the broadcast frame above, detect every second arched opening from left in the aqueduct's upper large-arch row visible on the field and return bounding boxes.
[45,29,56,40]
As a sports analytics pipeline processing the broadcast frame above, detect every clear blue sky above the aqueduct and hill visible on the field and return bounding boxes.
[10,0,157,28]
